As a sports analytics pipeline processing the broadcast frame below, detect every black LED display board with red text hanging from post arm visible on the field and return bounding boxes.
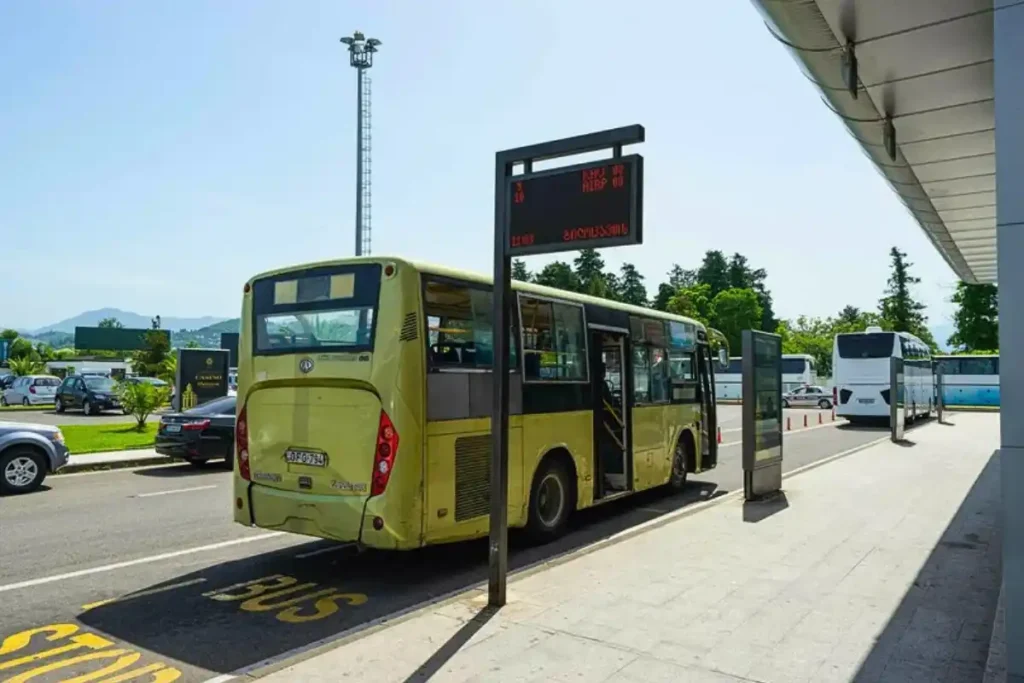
[507,155,643,256]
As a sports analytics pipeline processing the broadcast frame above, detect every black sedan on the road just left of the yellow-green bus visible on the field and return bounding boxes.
[157,396,234,467]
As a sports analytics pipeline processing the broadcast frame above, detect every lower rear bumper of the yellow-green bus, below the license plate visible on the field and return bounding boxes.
[234,483,419,550]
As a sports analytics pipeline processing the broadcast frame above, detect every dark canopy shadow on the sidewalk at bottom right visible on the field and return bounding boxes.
[853,451,1002,683]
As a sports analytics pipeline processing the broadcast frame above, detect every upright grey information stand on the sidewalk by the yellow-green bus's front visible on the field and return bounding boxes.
[742,330,782,501]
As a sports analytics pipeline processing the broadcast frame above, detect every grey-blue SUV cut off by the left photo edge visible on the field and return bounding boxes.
[0,422,70,494]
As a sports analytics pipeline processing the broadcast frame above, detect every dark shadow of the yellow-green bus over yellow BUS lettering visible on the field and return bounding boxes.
[78,479,724,681]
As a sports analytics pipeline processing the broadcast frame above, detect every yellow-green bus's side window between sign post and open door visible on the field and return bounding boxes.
[519,297,588,382]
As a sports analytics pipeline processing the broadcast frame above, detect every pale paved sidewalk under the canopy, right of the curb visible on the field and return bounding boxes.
[258,414,1000,683]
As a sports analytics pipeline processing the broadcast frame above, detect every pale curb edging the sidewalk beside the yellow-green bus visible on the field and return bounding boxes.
[232,436,889,683]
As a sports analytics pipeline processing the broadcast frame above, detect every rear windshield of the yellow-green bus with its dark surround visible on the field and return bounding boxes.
[253,263,381,355]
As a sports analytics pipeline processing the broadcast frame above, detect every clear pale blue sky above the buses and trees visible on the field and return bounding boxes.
[0,0,954,341]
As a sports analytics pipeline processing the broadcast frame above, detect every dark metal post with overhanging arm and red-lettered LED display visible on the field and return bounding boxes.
[487,125,644,607]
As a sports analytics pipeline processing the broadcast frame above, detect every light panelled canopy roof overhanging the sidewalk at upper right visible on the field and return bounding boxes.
[754,0,991,283]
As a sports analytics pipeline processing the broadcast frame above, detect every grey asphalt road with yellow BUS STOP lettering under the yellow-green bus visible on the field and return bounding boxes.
[0,417,887,683]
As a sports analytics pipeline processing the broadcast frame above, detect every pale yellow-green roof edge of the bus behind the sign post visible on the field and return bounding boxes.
[249,256,707,332]
